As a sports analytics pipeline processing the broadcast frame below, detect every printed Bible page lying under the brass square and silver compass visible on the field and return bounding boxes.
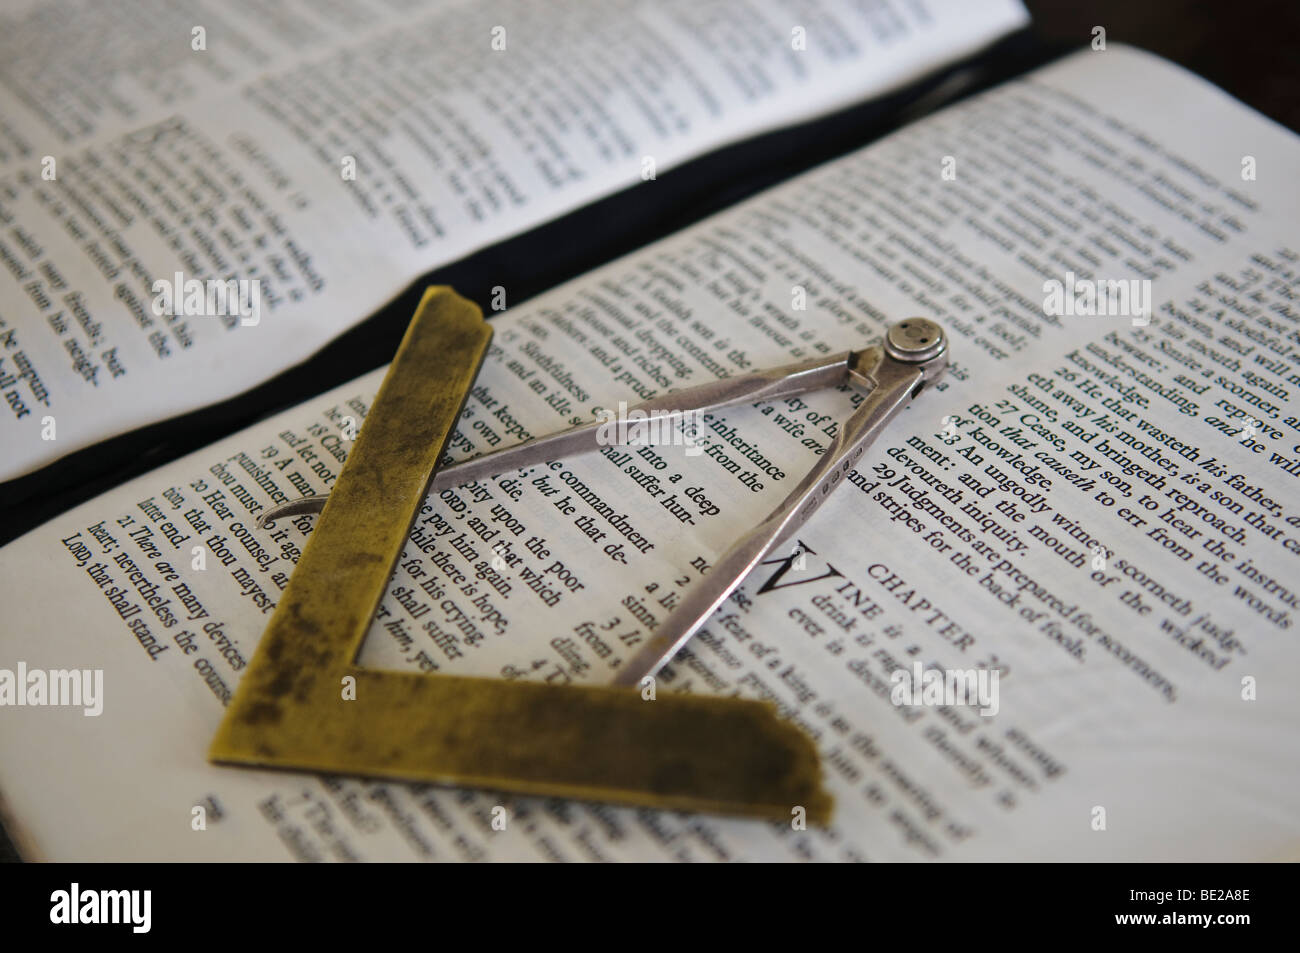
[0,47,1300,861]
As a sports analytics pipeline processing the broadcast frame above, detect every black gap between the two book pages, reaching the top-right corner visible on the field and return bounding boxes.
[0,0,1300,859]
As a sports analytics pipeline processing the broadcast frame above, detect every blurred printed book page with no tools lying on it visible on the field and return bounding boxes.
[0,0,1024,480]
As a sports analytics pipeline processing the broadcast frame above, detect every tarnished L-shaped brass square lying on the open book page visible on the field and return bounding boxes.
[209,287,831,823]
